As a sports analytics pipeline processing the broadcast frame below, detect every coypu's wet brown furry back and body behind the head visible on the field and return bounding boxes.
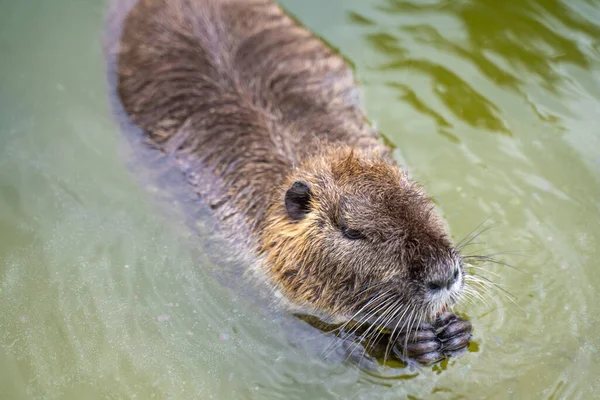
[110,0,377,230]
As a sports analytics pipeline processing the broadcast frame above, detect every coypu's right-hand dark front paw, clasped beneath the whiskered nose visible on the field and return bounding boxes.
[435,313,473,357]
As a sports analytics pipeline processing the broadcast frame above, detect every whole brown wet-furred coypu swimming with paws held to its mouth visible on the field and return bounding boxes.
[108,0,471,364]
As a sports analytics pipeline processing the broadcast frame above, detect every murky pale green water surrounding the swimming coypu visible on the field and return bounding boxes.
[0,0,600,399]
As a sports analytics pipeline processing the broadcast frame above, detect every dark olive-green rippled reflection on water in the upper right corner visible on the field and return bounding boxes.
[360,0,600,138]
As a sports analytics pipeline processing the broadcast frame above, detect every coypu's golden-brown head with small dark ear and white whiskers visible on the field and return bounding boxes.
[261,149,465,325]
